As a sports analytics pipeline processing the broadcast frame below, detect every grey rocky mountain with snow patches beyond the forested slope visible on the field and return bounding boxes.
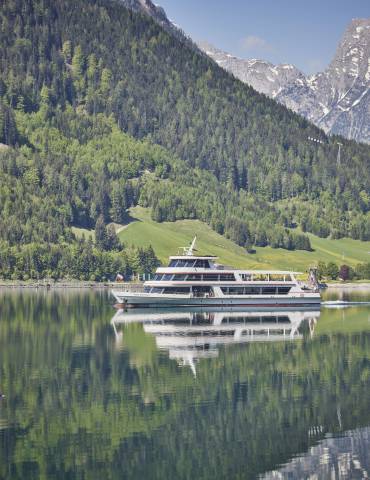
[199,19,370,143]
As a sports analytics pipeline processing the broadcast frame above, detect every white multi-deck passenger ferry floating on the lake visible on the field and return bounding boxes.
[112,237,321,308]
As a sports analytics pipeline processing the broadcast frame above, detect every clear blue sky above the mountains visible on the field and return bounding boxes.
[155,0,370,73]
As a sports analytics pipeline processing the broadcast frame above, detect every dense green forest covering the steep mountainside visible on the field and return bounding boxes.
[0,0,370,279]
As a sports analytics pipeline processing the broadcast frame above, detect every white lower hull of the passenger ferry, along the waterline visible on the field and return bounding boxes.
[112,291,321,308]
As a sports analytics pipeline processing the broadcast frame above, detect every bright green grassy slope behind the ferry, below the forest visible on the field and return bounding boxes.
[119,207,370,271]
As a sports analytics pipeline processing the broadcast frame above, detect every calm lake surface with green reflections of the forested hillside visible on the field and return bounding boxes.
[0,290,370,480]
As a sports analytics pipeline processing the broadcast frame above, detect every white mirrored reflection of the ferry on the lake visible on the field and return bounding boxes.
[111,307,320,375]
